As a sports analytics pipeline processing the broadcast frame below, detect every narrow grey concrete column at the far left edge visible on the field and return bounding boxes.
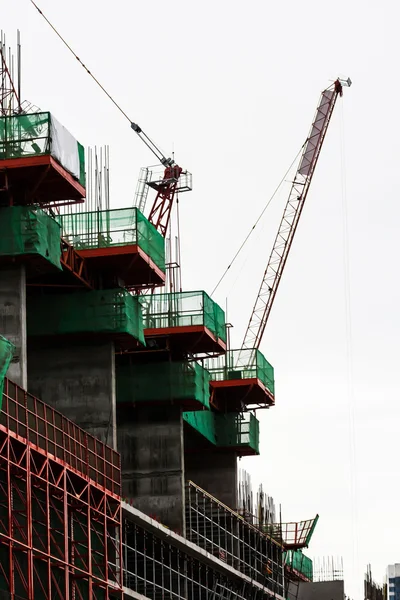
[0,265,27,390]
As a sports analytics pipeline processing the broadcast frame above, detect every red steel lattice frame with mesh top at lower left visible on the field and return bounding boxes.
[0,380,122,600]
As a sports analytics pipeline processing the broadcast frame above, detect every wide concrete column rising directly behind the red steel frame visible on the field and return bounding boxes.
[28,342,117,448]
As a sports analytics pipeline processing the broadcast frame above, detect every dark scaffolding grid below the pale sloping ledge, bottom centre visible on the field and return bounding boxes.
[122,507,280,600]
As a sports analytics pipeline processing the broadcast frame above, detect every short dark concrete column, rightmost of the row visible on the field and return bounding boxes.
[185,449,238,510]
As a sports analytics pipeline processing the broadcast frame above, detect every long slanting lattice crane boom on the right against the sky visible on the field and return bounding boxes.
[242,79,351,350]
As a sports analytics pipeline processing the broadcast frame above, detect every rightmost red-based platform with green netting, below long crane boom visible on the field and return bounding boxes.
[205,350,275,411]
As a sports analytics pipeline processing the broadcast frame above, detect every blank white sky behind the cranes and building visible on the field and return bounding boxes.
[1,0,400,600]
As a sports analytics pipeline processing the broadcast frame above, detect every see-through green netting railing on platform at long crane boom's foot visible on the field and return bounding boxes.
[205,348,275,394]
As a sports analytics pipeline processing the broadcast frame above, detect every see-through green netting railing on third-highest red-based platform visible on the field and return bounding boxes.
[140,292,226,342]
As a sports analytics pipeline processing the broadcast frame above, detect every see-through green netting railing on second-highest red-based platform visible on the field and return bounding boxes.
[57,207,165,272]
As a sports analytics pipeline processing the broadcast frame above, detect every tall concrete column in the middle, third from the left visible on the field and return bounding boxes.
[117,405,185,534]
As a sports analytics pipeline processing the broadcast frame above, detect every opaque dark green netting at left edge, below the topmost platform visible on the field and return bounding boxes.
[0,206,61,269]
